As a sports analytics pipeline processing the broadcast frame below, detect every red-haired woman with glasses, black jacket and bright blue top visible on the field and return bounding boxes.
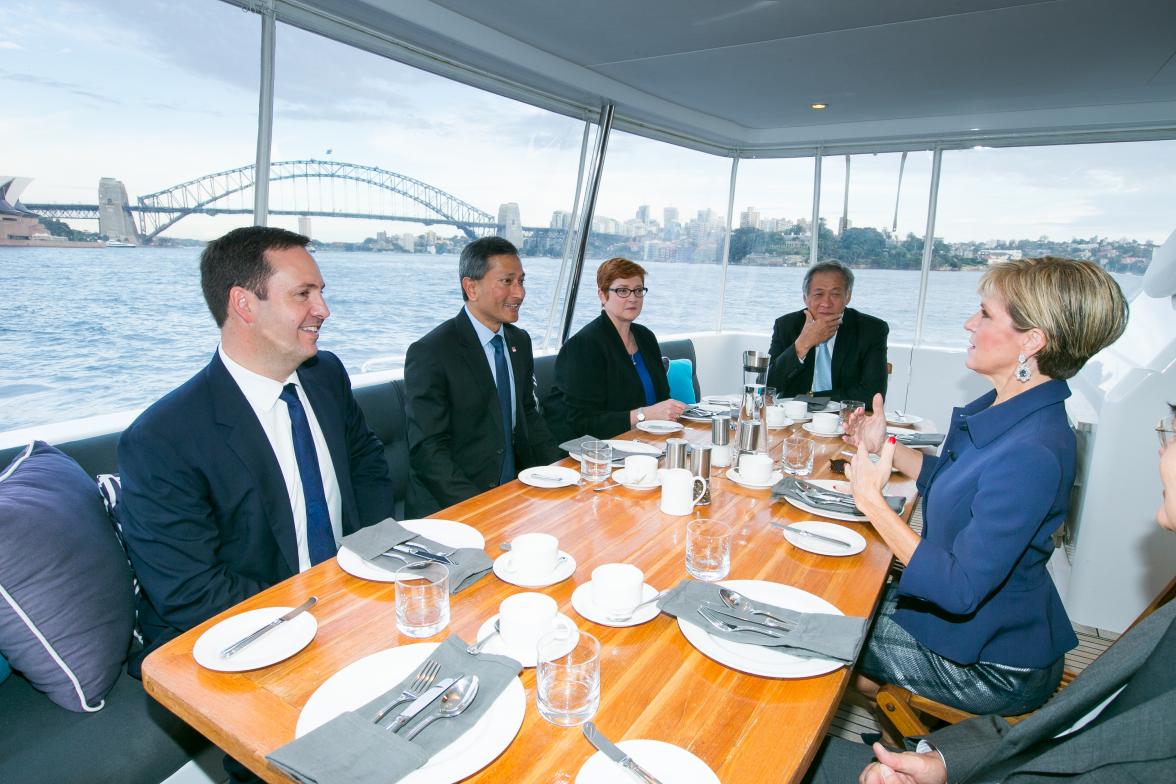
[543,257,686,441]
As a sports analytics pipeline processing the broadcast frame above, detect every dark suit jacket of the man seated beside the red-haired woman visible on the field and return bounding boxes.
[405,308,562,516]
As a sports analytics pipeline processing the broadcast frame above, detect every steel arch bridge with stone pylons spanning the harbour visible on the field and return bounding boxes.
[25,159,585,243]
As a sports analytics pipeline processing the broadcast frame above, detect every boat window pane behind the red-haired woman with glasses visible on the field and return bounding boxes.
[570,130,731,339]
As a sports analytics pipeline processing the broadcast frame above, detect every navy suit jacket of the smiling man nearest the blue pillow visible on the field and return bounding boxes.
[118,351,393,646]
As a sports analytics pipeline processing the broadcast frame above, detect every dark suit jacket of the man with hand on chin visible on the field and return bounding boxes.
[768,308,890,406]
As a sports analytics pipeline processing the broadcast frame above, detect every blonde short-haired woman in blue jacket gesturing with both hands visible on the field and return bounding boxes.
[846,256,1128,716]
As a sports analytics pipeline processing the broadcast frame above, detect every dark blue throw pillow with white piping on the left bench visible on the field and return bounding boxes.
[0,441,134,712]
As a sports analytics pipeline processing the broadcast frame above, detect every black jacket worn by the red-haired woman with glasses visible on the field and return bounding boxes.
[543,311,669,442]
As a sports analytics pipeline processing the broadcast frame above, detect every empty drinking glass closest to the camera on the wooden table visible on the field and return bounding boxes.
[535,626,600,726]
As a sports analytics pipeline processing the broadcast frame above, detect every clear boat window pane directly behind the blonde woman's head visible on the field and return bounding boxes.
[923,141,1176,347]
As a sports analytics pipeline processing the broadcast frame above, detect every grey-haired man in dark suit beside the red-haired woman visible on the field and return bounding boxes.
[405,236,562,516]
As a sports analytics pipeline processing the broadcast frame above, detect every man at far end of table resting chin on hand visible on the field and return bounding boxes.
[768,261,890,406]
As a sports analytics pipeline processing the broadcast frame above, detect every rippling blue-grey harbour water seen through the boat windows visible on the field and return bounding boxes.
[0,248,1138,431]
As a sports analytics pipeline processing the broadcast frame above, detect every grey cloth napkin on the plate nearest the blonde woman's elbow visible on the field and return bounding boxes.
[659,579,868,664]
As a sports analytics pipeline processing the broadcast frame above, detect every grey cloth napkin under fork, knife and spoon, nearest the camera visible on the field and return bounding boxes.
[266,637,522,784]
